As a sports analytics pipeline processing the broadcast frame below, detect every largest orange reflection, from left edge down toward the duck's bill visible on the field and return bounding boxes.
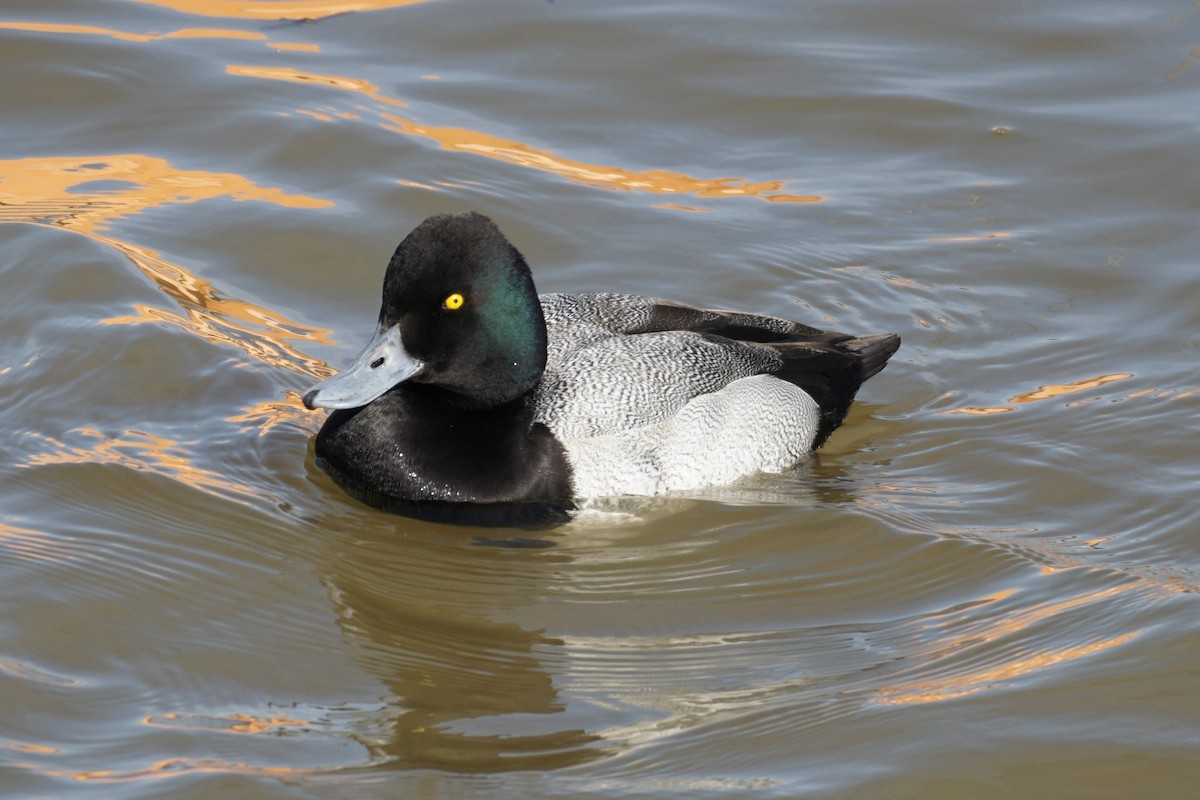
[0,154,332,375]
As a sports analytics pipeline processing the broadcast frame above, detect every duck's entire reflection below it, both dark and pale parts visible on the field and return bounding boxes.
[308,450,873,772]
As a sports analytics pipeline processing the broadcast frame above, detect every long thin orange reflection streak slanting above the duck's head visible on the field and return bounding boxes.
[227,65,824,209]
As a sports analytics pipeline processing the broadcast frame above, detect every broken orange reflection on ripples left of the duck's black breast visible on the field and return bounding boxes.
[22,428,264,500]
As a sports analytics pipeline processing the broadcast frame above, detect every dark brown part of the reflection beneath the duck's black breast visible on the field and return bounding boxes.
[325,518,605,771]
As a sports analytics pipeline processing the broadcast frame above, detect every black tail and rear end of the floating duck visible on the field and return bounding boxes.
[767,333,900,450]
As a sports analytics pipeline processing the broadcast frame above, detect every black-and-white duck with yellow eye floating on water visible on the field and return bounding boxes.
[302,211,900,527]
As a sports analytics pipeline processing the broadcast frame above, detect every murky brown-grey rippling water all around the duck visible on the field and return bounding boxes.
[0,0,1200,799]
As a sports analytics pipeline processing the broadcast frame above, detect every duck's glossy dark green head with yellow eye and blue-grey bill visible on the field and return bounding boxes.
[304,211,546,408]
